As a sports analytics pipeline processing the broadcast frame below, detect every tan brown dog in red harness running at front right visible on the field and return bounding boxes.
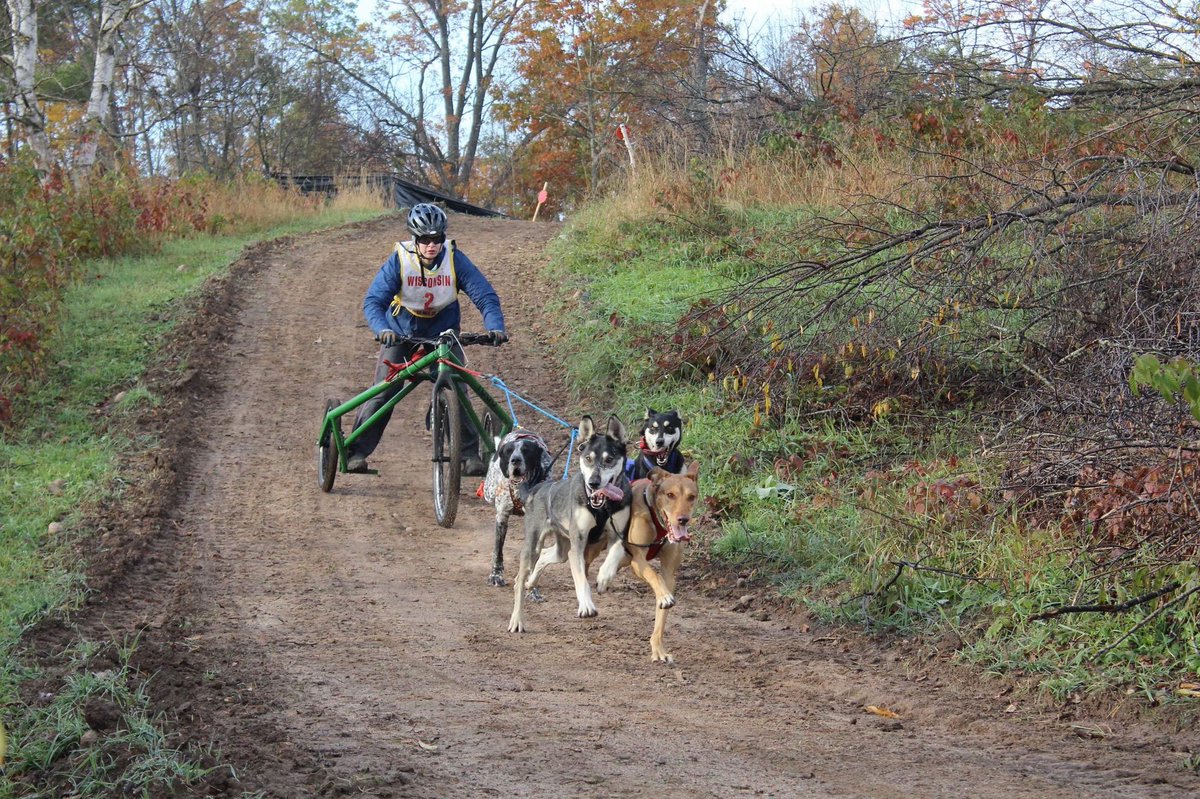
[596,461,700,663]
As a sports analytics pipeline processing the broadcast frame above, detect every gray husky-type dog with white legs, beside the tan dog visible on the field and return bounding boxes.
[509,416,632,632]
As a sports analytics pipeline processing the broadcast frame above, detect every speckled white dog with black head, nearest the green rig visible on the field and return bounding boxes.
[481,427,553,585]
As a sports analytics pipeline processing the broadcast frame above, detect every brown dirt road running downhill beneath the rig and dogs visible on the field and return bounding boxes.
[65,216,1200,799]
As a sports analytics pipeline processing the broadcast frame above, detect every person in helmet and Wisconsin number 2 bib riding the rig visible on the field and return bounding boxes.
[346,203,509,475]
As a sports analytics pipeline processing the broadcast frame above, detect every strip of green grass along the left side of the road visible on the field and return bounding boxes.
[0,203,378,799]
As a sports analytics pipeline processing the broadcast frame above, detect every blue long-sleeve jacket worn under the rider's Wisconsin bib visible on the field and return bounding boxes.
[362,241,504,338]
